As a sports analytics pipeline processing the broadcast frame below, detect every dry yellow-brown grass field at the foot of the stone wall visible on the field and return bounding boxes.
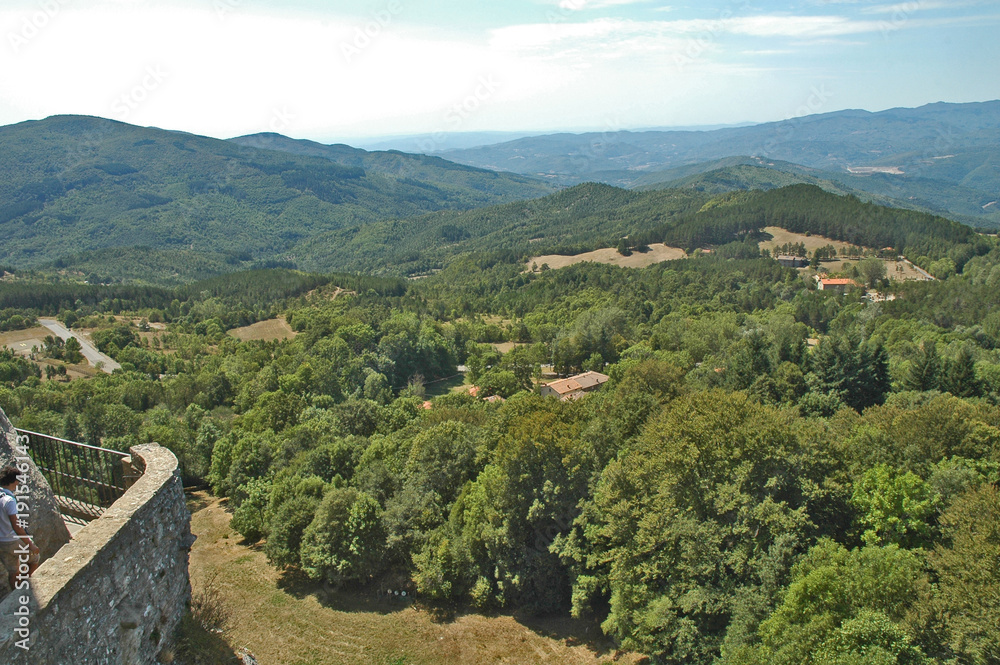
[189,492,645,665]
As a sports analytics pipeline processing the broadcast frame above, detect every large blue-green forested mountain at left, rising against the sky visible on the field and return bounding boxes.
[0,116,552,270]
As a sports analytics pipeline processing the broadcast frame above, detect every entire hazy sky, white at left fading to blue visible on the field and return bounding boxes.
[0,0,1000,142]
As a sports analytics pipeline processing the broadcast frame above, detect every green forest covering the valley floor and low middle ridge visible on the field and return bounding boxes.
[0,179,1000,665]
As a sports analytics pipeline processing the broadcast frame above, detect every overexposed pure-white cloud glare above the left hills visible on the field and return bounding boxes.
[0,3,562,137]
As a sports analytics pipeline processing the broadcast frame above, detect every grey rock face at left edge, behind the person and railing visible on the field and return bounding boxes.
[0,409,69,568]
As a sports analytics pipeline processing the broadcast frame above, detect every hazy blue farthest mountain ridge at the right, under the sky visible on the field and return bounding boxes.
[442,101,1000,227]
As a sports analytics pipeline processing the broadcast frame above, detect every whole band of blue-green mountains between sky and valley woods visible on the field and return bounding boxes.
[0,102,1000,283]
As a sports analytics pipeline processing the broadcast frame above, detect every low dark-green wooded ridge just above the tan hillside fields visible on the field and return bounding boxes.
[290,183,978,274]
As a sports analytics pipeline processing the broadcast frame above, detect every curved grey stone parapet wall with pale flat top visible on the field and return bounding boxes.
[0,444,194,665]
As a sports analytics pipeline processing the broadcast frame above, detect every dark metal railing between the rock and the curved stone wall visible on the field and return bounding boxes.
[17,429,141,522]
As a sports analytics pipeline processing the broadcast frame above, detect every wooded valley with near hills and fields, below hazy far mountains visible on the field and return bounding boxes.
[0,100,1000,665]
